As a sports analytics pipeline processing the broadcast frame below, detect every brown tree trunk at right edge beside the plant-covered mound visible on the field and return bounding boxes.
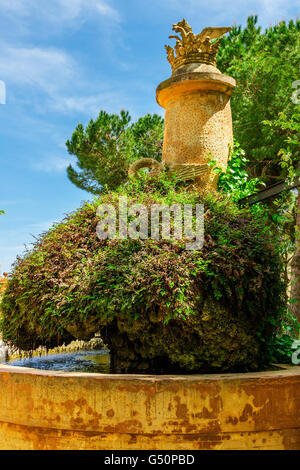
[290,187,300,323]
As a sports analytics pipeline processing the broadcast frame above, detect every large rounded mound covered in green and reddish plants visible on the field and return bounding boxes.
[1,175,286,372]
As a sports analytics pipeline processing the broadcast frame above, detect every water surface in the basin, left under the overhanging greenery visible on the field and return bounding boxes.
[6,349,111,374]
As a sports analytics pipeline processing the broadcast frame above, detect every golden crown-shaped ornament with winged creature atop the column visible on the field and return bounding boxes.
[165,19,231,73]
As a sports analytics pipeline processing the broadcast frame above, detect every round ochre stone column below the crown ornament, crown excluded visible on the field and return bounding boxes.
[156,64,235,190]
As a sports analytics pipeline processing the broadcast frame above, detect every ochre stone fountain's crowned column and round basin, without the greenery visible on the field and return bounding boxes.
[0,20,300,450]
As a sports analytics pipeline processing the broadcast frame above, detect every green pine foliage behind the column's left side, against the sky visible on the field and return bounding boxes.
[66,110,164,194]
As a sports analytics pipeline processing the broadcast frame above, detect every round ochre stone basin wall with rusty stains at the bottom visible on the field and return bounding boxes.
[0,365,300,450]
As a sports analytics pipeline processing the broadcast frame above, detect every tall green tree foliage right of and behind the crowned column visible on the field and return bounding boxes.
[217,17,300,184]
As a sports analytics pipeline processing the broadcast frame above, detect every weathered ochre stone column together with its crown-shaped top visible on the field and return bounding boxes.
[156,20,235,190]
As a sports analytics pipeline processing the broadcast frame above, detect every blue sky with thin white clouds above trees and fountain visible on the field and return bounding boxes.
[0,0,300,273]
